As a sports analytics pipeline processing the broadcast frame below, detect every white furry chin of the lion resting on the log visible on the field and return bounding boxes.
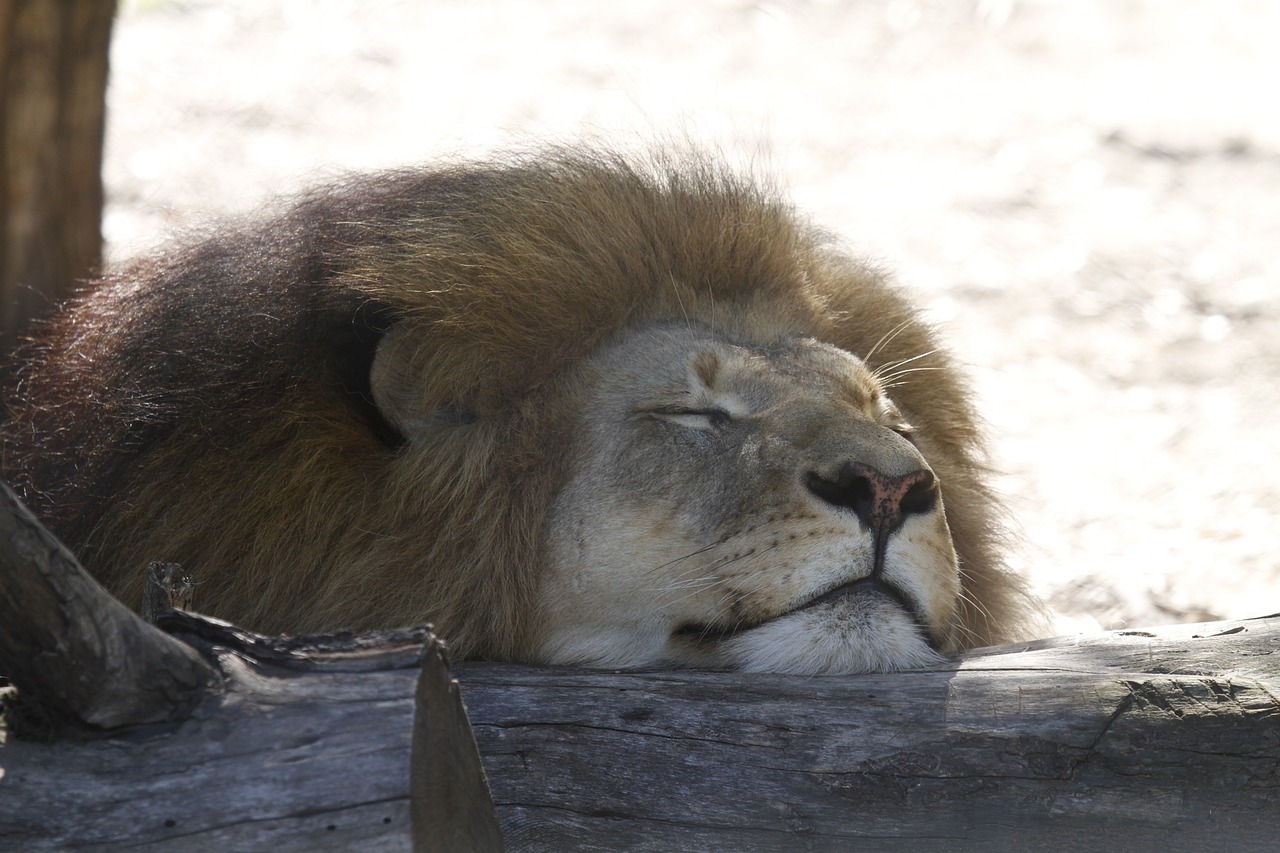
[669,596,942,675]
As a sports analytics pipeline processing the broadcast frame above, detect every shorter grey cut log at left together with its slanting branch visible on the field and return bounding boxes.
[0,488,502,852]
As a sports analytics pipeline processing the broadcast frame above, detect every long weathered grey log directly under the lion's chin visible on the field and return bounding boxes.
[458,617,1280,852]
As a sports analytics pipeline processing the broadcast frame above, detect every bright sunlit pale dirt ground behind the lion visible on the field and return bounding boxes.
[106,0,1280,633]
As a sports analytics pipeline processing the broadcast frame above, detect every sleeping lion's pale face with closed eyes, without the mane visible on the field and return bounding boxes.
[539,325,960,672]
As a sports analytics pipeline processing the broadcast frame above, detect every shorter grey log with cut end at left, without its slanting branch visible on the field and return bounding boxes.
[0,613,502,853]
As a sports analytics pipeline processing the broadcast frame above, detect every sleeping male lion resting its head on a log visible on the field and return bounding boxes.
[3,150,1034,674]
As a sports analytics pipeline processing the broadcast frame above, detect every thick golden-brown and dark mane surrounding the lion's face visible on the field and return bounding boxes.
[3,151,1028,658]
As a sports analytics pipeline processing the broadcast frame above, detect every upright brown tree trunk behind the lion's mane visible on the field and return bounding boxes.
[0,0,115,350]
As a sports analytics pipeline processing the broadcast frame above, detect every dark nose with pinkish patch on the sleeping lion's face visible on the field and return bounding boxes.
[804,462,938,530]
